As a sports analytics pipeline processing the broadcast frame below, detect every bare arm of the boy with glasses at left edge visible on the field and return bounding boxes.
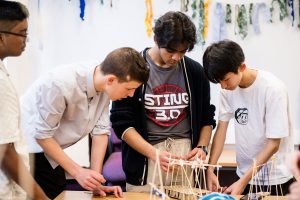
[1,144,46,199]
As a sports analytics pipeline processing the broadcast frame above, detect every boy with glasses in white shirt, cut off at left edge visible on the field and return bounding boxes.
[0,1,48,200]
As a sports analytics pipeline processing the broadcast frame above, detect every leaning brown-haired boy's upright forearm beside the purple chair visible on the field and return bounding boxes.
[91,134,108,173]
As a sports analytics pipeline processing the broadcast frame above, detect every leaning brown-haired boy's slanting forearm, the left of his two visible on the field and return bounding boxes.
[37,138,81,177]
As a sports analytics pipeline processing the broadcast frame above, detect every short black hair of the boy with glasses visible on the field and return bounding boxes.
[0,0,29,31]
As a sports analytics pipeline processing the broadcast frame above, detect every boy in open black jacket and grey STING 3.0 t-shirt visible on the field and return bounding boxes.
[111,12,215,192]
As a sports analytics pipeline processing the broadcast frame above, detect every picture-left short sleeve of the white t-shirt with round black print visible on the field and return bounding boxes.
[219,90,233,122]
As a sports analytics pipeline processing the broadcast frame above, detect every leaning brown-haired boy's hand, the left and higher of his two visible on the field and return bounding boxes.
[74,168,106,191]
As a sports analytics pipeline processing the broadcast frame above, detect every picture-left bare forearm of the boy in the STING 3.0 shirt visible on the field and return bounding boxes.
[123,128,156,160]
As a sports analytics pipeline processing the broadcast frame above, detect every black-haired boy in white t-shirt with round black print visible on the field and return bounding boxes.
[203,40,293,195]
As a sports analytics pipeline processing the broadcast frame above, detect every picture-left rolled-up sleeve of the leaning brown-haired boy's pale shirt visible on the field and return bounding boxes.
[35,83,66,139]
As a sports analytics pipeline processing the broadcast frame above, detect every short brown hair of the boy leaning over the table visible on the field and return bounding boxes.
[101,47,149,83]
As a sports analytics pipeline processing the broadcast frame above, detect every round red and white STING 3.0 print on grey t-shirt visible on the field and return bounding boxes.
[144,84,189,126]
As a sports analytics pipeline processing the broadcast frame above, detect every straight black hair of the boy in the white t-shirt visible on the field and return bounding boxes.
[203,40,245,83]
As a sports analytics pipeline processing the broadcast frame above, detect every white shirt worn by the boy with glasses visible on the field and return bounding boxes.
[0,60,29,199]
